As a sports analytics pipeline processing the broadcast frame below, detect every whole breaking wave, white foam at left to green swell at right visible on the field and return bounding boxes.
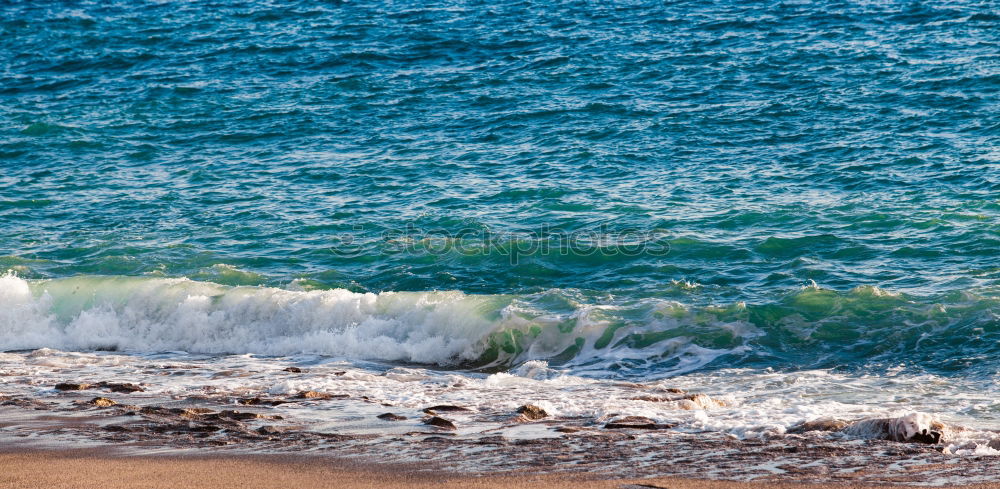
[0,274,1000,376]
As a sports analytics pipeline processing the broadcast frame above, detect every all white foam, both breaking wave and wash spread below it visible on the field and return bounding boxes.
[0,275,1000,455]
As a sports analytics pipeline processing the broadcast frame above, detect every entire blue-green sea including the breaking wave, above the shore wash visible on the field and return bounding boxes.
[0,0,1000,378]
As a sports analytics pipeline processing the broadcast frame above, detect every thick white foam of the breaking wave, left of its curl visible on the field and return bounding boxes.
[0,275,502,363]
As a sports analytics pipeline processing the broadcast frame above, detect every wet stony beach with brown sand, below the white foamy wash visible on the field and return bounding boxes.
[0,389,1000,488]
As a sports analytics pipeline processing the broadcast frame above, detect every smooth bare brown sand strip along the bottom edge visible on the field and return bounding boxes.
[0,447,1000,489]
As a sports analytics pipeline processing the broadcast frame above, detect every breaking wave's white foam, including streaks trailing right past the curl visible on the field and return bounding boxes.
[0,274,755,372]
